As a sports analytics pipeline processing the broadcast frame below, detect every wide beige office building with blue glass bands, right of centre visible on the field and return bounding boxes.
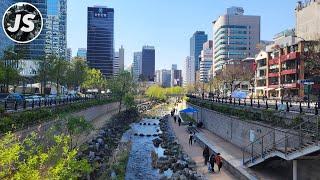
[213,7,260,74]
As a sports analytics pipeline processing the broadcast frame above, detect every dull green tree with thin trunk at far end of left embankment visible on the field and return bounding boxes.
[108,71,136,113]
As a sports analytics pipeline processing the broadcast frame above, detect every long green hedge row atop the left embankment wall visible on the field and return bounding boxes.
[0,99,114,134]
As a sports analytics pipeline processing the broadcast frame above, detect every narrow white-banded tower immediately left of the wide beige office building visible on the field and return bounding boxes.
[200,40,213,82]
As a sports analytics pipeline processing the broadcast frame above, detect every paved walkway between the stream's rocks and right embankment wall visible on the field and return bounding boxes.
[169,117,237,180]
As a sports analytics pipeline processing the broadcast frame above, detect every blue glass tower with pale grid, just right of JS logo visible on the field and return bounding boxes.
[44,0,67,60]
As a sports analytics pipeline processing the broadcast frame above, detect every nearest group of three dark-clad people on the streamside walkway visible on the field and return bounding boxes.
[203,146,222,173]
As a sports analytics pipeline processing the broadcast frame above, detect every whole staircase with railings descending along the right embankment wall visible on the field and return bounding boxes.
[243,120,320,167]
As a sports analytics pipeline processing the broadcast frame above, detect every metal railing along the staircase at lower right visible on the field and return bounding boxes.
[243,118,319,165]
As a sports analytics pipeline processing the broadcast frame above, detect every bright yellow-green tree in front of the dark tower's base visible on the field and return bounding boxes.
[82,68,107,91]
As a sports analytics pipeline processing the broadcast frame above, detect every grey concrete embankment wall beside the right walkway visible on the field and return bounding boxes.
[187,103,285,152]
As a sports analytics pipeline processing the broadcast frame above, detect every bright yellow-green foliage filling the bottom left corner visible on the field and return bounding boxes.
[0,133,92,180]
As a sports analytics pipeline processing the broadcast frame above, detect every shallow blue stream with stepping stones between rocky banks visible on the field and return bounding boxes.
[121,119,172,180]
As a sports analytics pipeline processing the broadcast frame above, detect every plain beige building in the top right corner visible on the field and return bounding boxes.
[296,0,320,41]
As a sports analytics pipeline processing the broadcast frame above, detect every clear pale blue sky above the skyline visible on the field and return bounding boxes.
[68,0,296,69]
